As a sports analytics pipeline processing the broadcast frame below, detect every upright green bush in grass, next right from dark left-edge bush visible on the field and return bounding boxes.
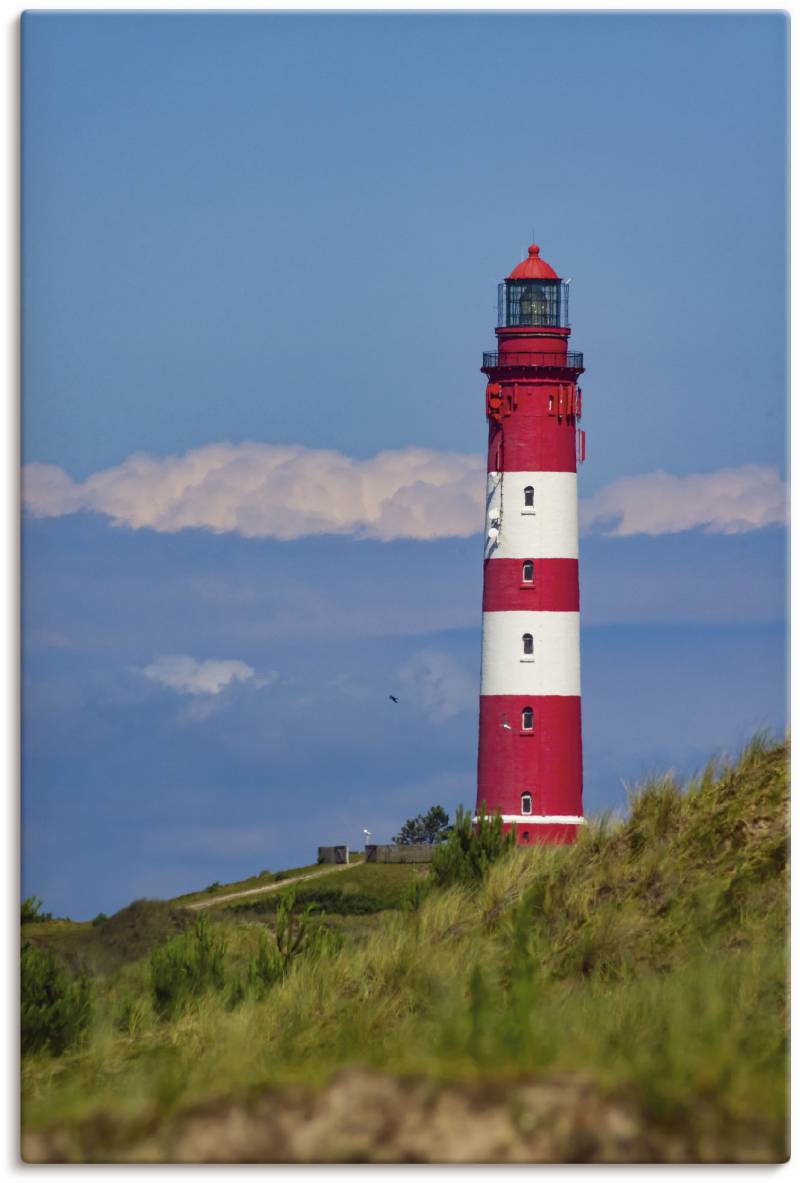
[150,916,226,1019]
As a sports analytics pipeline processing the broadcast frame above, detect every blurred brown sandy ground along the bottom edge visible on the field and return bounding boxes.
[22,1068,785,1163]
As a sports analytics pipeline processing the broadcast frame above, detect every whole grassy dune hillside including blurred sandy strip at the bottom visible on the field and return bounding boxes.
[24,738,788,1162]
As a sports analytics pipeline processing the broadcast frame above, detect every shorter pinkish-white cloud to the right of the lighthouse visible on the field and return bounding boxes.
[581,464,788,538]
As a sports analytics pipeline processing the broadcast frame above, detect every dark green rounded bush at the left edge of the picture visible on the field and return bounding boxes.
[20,942,93,1055]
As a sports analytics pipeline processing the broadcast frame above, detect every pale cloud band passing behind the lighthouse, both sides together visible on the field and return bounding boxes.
[22,444,787,542]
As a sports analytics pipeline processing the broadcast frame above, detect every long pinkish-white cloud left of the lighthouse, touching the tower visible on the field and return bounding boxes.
[22,444,485,541]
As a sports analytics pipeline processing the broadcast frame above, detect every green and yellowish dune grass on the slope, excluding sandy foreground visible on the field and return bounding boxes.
[18,737,788,1159]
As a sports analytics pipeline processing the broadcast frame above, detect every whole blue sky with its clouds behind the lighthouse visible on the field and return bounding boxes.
[22,13,787,916]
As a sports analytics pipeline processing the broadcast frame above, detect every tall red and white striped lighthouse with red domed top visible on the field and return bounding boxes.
[477,244,586,846]
